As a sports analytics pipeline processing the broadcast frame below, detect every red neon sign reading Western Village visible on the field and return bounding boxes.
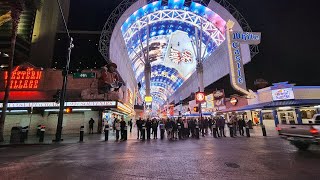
[4,66,42,90]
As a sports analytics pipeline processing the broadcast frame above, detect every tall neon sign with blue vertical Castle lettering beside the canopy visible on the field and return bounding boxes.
[226,20,261,95]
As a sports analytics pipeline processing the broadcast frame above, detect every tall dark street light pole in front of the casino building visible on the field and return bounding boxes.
[54,0,74,142]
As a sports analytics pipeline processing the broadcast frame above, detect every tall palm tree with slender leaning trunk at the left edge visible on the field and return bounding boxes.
[0,0,41,142]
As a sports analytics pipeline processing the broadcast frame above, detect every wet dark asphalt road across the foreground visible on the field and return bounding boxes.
[0,137,320,180]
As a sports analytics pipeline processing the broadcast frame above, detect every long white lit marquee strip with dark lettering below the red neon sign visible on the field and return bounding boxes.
[0,101,116,108]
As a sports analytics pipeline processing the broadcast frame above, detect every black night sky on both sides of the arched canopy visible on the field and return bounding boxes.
[55,0,320,94]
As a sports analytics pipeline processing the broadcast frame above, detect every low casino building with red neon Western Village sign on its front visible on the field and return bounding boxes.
[0,63,135,135]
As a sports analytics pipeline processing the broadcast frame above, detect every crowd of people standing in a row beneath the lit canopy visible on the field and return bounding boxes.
[131,116,246,140]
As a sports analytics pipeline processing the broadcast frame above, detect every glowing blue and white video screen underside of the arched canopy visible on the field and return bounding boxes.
[121,0,226,108]
